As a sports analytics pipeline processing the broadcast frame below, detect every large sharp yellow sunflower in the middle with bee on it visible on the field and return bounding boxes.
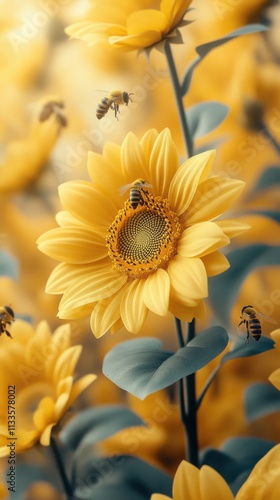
[38,129,248,337]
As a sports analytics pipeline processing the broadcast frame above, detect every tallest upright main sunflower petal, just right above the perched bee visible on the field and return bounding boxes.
[149,129,180,198]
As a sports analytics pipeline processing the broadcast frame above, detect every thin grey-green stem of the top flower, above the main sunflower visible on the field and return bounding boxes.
[164,42,193,157]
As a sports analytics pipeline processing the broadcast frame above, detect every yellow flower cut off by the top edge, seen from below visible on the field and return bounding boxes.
[66,0,191,51]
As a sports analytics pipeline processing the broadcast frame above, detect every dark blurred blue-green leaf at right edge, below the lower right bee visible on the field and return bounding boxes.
[245,383,280,422]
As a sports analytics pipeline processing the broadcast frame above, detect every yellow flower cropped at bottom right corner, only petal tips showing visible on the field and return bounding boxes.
[151,445,280,500]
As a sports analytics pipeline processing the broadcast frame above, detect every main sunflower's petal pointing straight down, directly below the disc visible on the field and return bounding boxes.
[120,279,148,333]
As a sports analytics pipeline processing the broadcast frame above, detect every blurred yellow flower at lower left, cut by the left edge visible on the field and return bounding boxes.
[0,319,96,457]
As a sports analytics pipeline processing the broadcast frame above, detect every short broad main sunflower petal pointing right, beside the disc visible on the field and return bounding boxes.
[177,222,230,257]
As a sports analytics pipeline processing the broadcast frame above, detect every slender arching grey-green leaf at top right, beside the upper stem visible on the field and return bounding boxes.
[182,24,268,95]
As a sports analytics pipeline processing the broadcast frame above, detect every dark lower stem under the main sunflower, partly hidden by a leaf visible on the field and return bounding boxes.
[175,318,199,467]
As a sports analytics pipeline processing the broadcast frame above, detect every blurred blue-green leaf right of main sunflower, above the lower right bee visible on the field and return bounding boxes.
[209,244,280,325]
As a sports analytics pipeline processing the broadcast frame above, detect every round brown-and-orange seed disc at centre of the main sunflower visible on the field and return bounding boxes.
[107,192,181,278]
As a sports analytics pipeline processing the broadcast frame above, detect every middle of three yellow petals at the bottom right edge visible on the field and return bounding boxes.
[200,465,233,500]
